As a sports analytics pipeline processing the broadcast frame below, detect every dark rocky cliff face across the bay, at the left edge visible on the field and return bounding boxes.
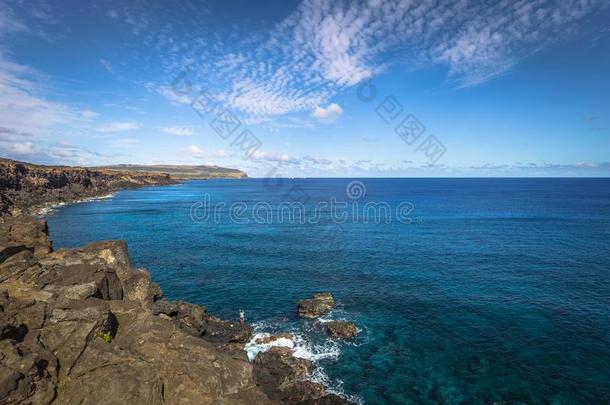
[0,159,175,214]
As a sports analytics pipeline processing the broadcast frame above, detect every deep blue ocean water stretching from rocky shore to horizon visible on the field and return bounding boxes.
[48,179,610,404]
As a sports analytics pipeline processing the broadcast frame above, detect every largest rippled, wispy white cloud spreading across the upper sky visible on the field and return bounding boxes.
[139,0,608,120]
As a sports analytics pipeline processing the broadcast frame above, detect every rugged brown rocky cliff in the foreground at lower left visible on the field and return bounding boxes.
[0,216,348,404]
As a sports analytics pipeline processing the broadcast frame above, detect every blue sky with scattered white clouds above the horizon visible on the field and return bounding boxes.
[0,0,610,177]
